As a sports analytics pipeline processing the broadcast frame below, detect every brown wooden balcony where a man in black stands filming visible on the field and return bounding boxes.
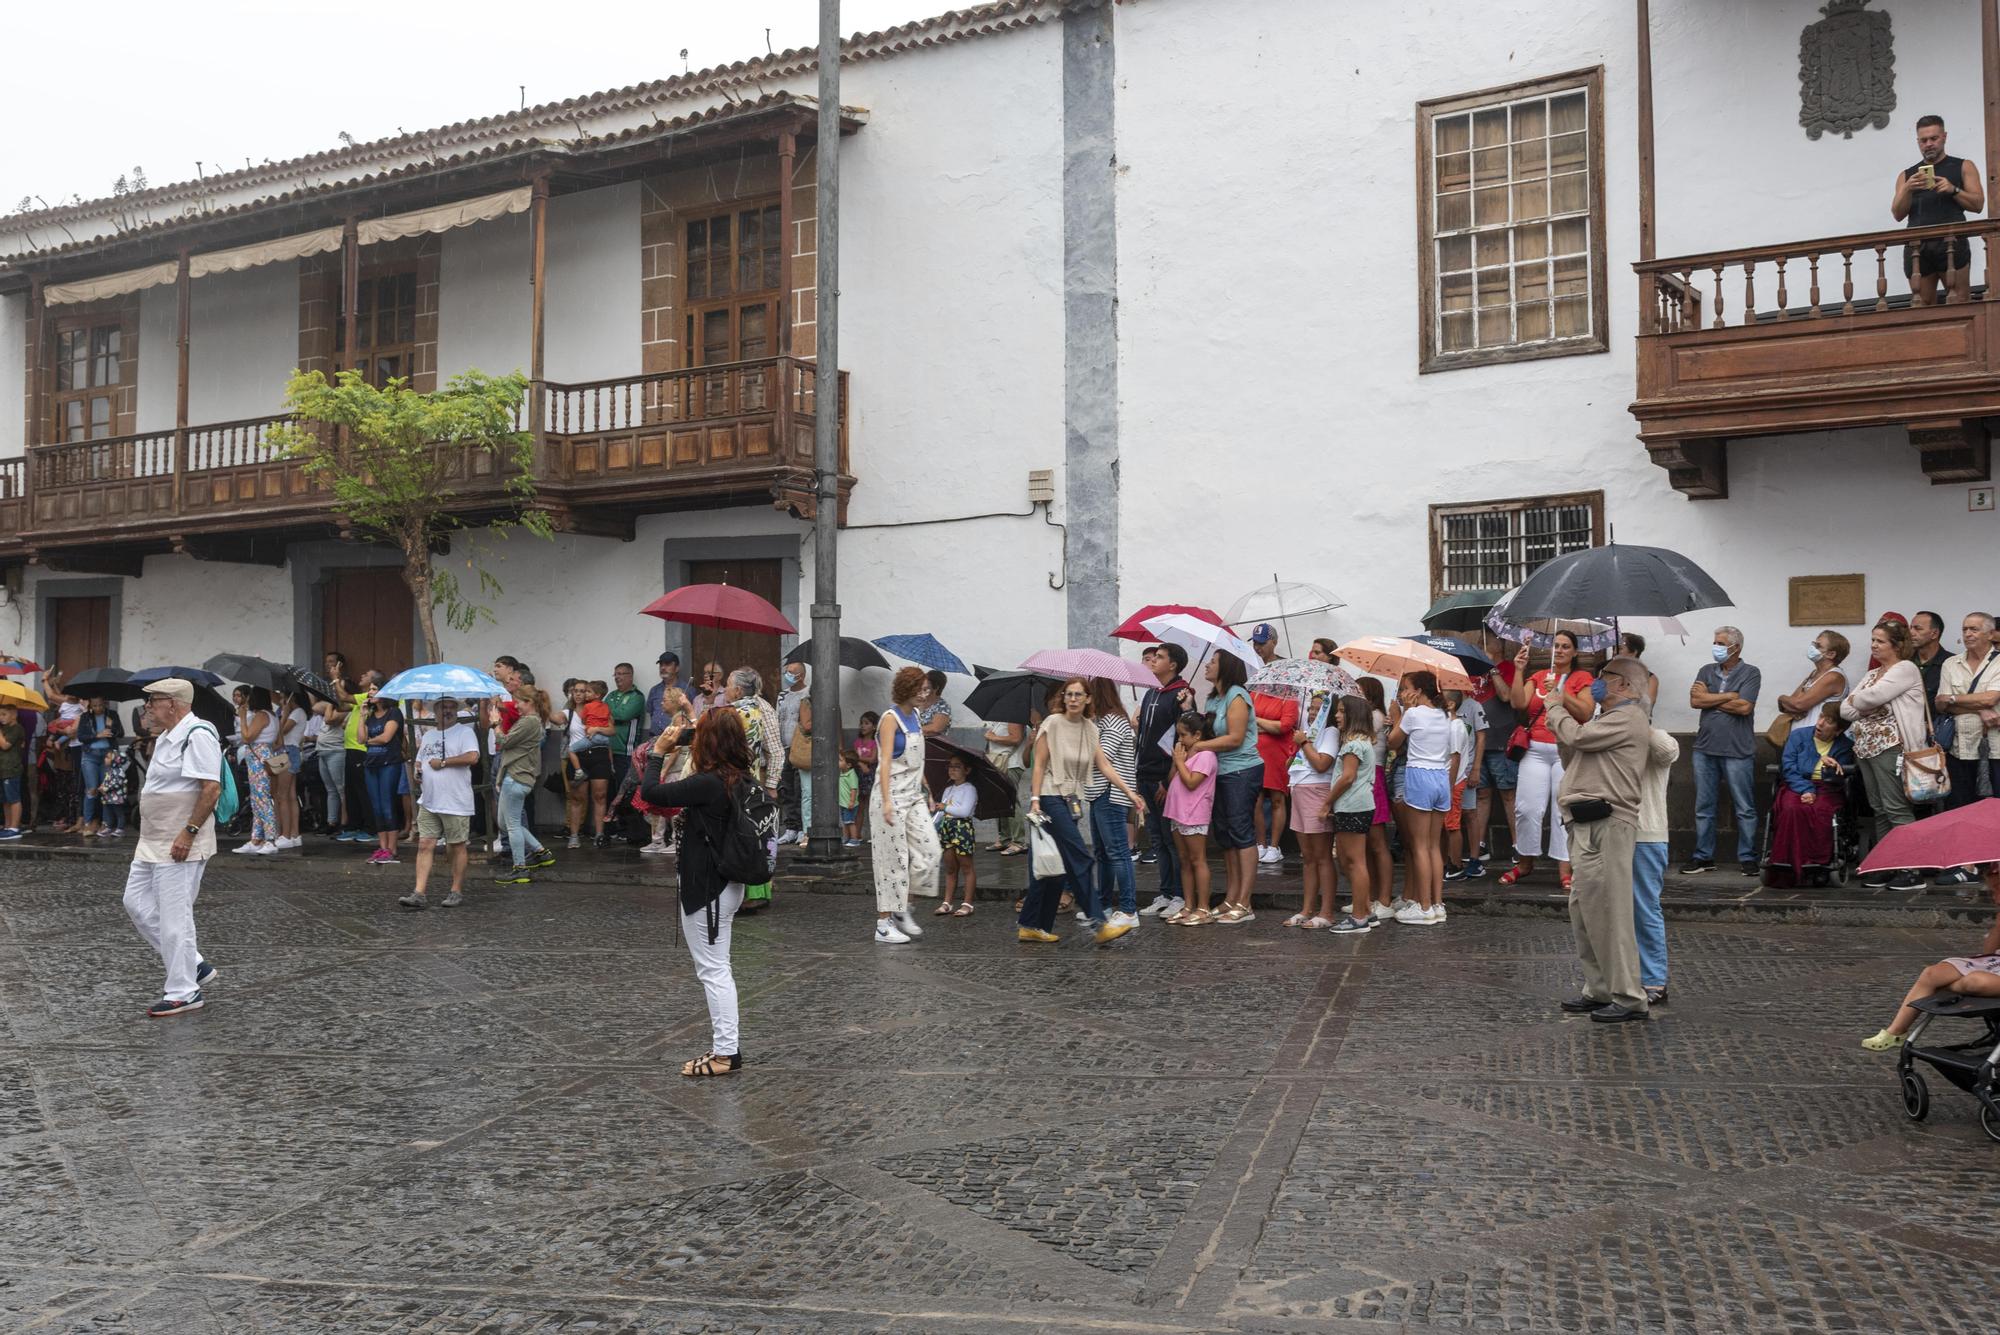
[1632,220,2000,500]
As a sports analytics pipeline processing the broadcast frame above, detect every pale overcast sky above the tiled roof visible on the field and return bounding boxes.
[0,0,948,212]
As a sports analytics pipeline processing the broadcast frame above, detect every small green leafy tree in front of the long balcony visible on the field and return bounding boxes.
[270,370,552,664]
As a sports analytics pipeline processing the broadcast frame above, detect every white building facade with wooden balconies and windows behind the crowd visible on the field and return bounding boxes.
[0,0,2000,727]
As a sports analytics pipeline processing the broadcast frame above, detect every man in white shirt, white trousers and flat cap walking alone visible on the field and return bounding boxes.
[126,677,222,1019]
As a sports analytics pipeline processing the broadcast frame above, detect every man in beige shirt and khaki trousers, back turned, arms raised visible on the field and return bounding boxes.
[1542,658,1652,1025]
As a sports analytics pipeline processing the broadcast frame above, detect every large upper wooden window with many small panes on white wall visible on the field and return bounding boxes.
[1418,70,1608,372]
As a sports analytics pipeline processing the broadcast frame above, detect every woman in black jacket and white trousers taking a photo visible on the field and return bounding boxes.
[644,709,750,1077]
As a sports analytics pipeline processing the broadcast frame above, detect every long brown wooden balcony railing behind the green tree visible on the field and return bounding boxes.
[0,358,854,574]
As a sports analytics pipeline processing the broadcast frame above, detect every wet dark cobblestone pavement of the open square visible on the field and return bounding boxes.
[0,857,2000,1333]
